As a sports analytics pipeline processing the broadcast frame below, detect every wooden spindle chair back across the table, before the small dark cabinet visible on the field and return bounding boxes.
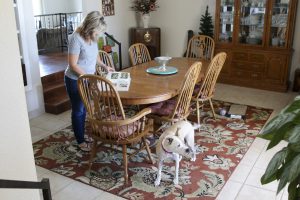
[128,43,151,65]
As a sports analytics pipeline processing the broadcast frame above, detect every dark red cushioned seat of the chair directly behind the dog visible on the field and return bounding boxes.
[149,98,176,116]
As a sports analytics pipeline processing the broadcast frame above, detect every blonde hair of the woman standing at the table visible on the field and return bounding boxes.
[76,11,106,40]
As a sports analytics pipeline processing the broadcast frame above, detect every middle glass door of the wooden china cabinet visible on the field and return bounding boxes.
[238,0,266,45]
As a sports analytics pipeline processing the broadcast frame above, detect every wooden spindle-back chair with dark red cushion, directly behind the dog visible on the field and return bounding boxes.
[149,62,202,133]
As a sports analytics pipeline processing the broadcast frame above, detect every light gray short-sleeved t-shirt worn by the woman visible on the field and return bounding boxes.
[65,32,98,80]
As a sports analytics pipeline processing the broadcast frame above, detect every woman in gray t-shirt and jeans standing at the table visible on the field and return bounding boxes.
[65,11,113,151]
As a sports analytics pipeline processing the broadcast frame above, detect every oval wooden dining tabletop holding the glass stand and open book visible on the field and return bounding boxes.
[119,58,210,105]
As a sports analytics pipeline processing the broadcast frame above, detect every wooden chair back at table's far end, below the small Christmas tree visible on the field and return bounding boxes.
[186,35,215,60]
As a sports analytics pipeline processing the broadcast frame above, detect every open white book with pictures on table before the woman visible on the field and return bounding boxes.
[106,72,131,91]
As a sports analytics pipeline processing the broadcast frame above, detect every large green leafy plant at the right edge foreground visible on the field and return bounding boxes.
[258,96,300,200]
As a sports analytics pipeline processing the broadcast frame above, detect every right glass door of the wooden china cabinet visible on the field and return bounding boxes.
[269,0,290,47]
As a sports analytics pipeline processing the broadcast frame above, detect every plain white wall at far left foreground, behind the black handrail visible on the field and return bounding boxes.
[0,1,40,200]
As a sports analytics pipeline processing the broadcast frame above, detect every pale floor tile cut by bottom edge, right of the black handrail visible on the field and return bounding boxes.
[53,181,105,200]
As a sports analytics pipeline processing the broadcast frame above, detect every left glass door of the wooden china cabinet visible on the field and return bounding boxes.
[218,0,235,43]
